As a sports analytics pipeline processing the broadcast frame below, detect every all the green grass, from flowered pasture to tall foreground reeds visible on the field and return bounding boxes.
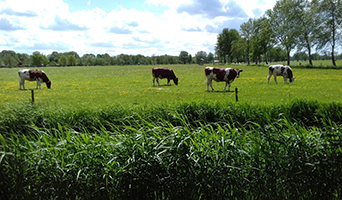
[0,65,342,199]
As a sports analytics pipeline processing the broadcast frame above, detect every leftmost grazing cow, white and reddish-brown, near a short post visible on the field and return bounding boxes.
[18,69,51,90]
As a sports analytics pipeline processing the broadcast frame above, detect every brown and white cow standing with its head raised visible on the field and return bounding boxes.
[204,67,243,92]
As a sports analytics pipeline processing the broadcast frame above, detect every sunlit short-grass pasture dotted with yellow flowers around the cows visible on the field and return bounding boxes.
[0,65,342,108]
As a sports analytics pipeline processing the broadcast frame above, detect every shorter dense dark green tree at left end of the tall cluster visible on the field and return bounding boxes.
[215,28,240,63]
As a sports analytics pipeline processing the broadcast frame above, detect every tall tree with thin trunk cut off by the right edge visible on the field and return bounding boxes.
[312,0,342,66]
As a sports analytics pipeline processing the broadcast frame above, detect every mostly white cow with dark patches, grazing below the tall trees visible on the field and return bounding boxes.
[267,65,295,84]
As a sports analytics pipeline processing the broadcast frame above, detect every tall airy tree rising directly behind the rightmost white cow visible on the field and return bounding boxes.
[266,0,297,65]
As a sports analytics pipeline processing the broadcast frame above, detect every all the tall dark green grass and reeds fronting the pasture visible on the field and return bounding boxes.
[0,100,342,199]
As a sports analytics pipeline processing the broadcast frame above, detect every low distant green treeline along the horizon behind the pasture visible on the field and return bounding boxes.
[0,47,342,68]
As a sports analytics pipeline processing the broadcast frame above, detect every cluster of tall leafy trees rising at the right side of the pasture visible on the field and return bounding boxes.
[215,0,342,66]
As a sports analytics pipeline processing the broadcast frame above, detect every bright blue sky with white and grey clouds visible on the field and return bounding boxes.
[0,0,276,56]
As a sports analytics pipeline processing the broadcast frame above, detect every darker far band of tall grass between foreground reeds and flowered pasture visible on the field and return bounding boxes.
[0,100,342,134]
